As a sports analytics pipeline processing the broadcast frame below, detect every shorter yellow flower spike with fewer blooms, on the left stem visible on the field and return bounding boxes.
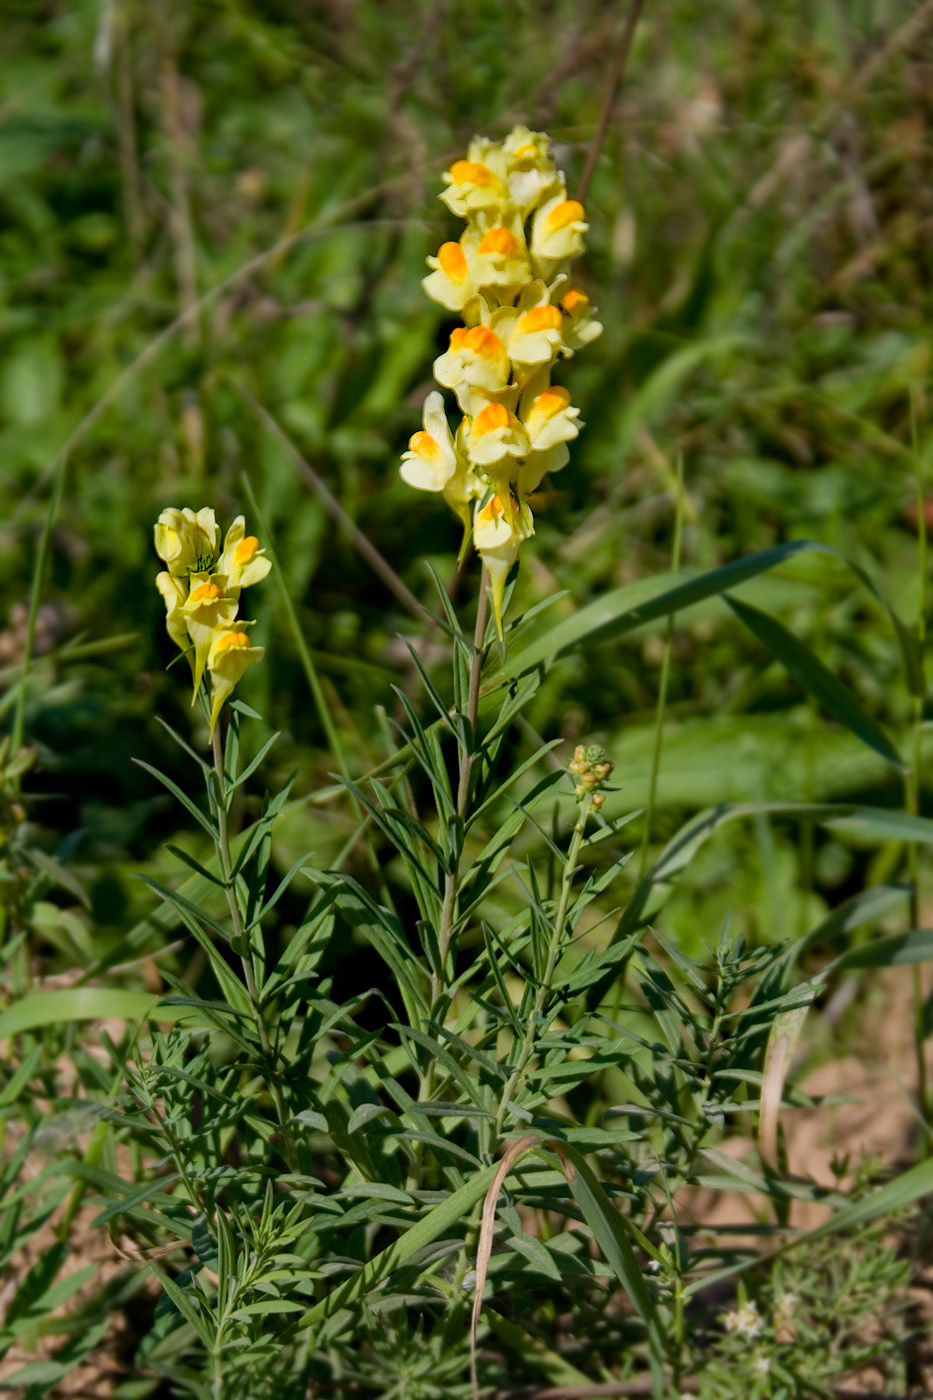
[156,505,272,736]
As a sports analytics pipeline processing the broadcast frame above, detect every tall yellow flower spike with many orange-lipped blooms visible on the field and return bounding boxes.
[401,126,602,637]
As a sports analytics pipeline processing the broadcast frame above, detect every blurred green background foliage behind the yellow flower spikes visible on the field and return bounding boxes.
[0,0,933,1041]
